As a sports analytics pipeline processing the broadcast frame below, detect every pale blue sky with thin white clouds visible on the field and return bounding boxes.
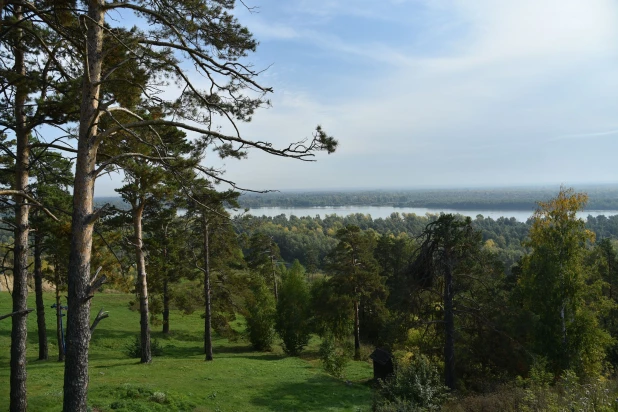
[97,0,618,196]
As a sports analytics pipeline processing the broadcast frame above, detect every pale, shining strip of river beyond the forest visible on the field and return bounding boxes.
[233,206,618,222]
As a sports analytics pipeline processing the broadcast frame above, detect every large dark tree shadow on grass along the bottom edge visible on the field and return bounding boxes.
[251,375,371,411]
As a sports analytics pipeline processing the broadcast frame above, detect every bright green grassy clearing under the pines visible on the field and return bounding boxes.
[0,292,372,411]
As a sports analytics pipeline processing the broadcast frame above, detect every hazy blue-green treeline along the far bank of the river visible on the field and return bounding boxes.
[240,185,618,210]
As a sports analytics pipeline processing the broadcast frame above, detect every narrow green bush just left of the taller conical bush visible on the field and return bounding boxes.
[247,278,276,351]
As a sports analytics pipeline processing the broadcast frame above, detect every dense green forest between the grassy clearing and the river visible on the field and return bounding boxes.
[3,188,618,411]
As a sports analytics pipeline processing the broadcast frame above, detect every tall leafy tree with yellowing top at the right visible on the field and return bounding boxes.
[520,188,610,375]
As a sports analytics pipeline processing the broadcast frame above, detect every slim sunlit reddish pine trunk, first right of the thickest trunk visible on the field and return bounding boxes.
[133,202,152,363]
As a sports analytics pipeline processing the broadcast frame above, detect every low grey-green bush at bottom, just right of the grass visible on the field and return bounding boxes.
[373,355,448,412]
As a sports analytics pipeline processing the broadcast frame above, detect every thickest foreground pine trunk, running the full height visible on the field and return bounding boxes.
[63,0,105,412]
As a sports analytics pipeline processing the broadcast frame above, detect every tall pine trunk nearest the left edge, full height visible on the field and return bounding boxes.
[9,5,29,412]
